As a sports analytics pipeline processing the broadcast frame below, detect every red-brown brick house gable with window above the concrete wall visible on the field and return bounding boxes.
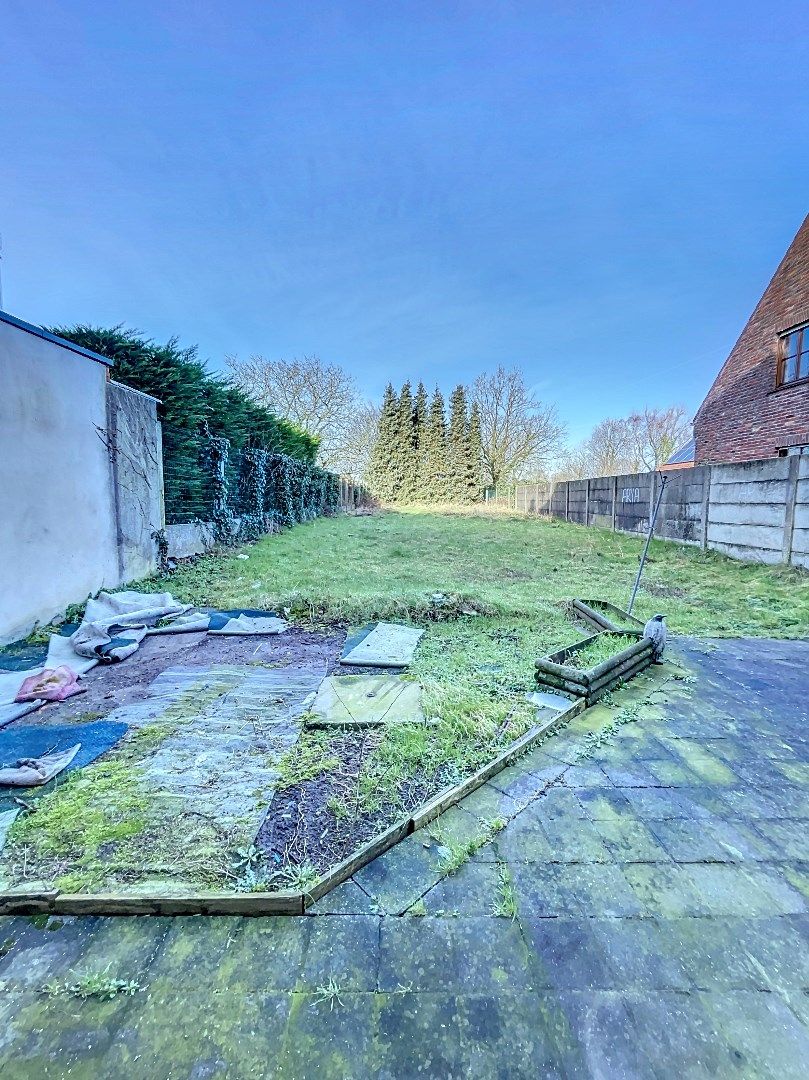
[693,216,809,464]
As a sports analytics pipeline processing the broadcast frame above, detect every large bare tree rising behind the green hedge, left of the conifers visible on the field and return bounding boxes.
[225,356,360,468]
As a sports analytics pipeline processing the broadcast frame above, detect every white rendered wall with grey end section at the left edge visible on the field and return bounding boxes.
[0,313,163,643]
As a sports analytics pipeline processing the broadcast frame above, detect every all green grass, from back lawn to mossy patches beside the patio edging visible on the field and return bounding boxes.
[17,509,809,885]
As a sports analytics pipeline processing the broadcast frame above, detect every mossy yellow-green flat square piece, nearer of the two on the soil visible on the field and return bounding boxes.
[309,675,424,727]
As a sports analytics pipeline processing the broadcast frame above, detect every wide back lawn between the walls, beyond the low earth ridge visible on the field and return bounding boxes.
[133,509,809,646]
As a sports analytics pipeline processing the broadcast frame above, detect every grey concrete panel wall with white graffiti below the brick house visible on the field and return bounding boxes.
[513,456,809,569]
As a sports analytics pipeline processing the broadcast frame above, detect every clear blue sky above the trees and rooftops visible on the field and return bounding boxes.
[0,0,809,438]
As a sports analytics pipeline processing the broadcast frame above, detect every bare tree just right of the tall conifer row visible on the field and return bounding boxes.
[470,367,565,484]
